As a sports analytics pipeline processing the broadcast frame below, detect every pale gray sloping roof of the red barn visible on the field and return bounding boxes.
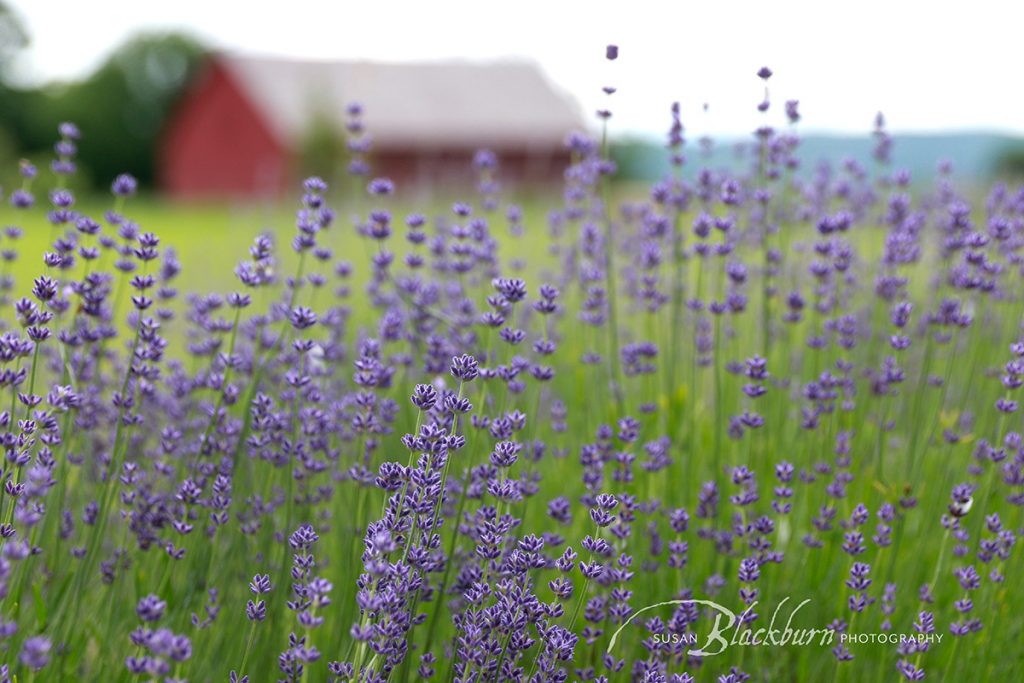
[218,54,585,148]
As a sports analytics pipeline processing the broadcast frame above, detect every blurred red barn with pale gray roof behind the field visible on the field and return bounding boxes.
[159,54,585,198]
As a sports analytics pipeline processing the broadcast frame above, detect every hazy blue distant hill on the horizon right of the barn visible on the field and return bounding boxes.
[614,133,1024,181]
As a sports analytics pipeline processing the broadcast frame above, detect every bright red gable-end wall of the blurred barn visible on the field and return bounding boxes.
[158,60,289,199]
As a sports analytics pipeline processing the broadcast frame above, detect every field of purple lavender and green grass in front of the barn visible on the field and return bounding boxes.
[0,56,1024,683]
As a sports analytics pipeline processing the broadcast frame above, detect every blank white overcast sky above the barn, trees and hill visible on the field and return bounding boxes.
[8,0,1024,136]
